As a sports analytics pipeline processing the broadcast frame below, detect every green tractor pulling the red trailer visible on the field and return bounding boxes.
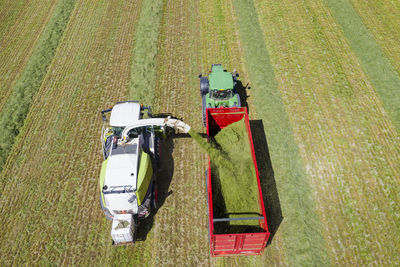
[199,64,241,126]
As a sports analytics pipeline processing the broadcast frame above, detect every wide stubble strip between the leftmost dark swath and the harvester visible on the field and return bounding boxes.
[0,1,140,266]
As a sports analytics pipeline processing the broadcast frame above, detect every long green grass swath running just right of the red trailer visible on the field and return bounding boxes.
[234,0,329,265]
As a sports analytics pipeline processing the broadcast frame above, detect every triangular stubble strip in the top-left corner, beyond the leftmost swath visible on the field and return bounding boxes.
[0,0,56,111]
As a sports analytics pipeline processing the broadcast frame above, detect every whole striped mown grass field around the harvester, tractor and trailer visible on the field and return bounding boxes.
[0,0,400,266]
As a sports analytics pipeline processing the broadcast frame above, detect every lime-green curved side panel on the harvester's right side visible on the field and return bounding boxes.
[136,151,153,205]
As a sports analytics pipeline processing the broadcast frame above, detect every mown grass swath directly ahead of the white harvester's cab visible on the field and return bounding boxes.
[129,0,163,105]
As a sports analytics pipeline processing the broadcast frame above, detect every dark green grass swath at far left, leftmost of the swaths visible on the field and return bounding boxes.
[0,0,76,170]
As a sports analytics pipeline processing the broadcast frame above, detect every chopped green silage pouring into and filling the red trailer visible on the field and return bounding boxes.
[189,119,261,232]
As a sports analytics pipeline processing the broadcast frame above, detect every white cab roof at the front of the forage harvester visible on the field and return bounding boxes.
[110,102,140,127]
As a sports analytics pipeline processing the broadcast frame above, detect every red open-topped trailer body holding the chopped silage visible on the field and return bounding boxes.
[206,108,270,256]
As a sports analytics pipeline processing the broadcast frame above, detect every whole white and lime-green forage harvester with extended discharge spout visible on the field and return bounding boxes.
[99,101,190,244]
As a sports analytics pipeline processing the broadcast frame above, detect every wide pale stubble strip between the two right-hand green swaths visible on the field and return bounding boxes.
[256,0,399,265]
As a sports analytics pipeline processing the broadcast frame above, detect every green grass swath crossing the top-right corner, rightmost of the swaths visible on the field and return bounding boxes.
[324,0,400,132]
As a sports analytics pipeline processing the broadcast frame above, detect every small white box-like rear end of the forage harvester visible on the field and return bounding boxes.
[111,214,134,244]
